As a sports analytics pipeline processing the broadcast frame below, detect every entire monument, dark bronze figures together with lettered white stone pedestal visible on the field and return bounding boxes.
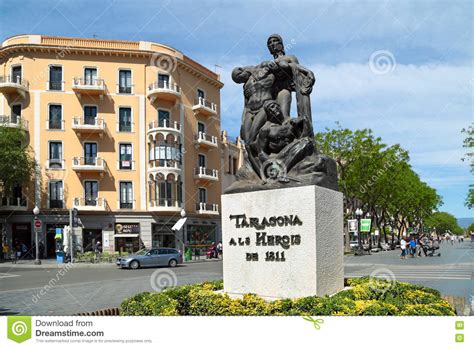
[222,34,344,299]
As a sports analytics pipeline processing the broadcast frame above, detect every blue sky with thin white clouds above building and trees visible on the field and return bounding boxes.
[0,0,474,217]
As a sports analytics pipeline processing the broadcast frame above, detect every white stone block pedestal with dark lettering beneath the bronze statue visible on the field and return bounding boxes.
[222,186,344,300]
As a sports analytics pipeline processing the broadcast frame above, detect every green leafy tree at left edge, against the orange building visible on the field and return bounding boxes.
[0,124,36,197]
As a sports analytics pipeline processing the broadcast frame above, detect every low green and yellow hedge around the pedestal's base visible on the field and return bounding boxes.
[120,277,455,316]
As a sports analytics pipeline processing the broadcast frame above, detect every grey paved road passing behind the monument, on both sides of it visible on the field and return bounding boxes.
[0,242,474,315]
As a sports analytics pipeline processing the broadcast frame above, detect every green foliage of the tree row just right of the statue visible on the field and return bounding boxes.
[315,123,442,235]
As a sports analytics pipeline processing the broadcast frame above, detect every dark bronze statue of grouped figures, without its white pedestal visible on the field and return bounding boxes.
[224,34,337,193]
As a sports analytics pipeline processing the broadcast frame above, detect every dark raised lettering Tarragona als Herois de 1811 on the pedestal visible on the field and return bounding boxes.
[229,214,303,262]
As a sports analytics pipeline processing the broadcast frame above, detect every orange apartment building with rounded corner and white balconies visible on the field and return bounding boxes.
[0,35,229,257]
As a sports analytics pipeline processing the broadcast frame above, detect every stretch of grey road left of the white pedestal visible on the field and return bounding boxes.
[0,262,222,315]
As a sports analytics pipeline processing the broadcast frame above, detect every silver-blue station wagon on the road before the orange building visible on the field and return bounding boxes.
[116,248,183,269]
